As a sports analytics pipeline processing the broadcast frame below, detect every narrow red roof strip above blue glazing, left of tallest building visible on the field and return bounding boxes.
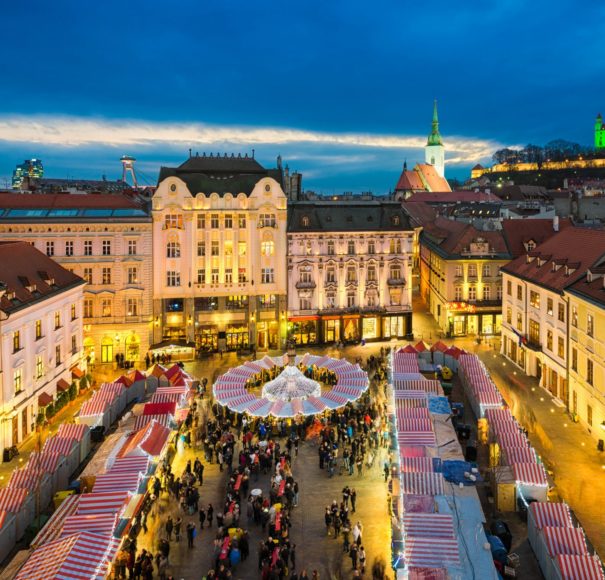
[0,192,139,209]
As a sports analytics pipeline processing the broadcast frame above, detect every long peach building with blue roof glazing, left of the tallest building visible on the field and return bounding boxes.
[0,194,152,363]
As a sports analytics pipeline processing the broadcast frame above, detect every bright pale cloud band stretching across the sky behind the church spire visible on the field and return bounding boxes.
[0,115,502,165]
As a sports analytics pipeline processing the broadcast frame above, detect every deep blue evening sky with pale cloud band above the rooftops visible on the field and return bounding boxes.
[0,0,605,193]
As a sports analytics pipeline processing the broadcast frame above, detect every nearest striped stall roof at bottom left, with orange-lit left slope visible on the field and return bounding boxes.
[15,532,121,580]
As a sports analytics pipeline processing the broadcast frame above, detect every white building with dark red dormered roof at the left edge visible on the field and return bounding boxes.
[0,242,86,450]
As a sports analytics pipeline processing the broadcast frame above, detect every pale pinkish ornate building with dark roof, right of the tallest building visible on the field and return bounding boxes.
[288,199,414,344]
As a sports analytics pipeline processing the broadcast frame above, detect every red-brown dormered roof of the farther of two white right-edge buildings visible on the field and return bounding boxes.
[502,227,605,291]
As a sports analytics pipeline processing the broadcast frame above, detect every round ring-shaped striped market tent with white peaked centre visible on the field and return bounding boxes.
[212,353,369,417]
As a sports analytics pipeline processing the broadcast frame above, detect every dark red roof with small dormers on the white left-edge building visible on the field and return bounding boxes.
[0,242,85,313]
